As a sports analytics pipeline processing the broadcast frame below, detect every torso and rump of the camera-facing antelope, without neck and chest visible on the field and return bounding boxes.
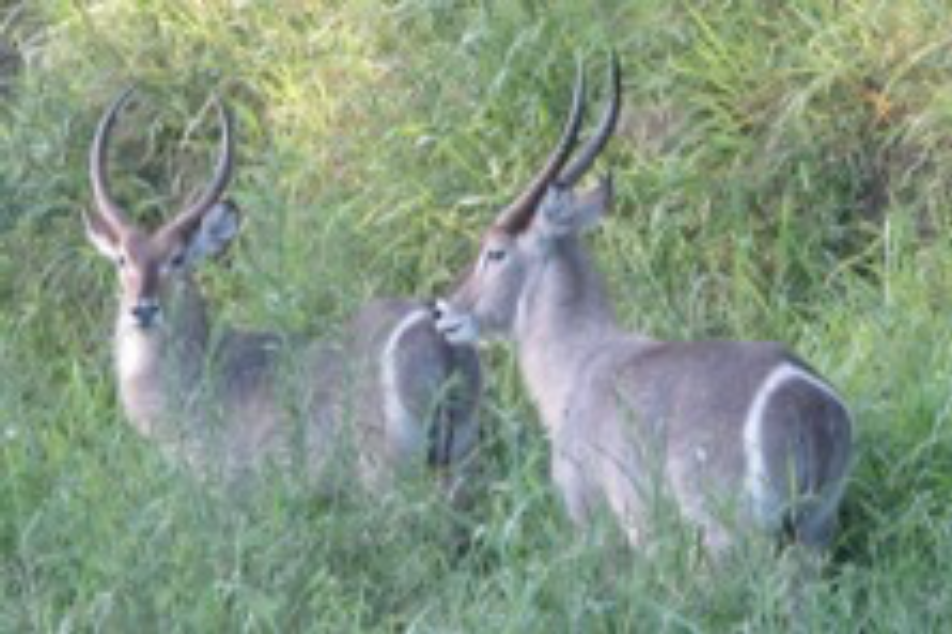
[195,299,480,488]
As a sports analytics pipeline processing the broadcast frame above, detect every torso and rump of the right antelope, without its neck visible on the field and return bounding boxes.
[567,341,850,544]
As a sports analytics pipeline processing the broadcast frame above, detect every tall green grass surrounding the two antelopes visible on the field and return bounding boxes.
[0,0,952,632]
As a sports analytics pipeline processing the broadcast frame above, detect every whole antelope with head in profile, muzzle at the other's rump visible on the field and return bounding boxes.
[437,58,852,552]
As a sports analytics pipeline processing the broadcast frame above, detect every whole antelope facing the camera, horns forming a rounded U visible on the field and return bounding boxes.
[85,90,480,494]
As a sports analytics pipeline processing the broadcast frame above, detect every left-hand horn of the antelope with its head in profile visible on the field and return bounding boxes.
[494,61,585,233]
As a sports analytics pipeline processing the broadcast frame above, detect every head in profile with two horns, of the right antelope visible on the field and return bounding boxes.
[437,56,621,343]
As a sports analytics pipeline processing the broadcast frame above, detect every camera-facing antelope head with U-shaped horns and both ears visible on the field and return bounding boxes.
[84,89,238,328]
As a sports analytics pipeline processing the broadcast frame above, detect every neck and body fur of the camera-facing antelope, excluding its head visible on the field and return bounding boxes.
[95,210,480,483]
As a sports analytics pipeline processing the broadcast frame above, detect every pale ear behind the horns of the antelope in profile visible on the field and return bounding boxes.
[534,175,615,238]
